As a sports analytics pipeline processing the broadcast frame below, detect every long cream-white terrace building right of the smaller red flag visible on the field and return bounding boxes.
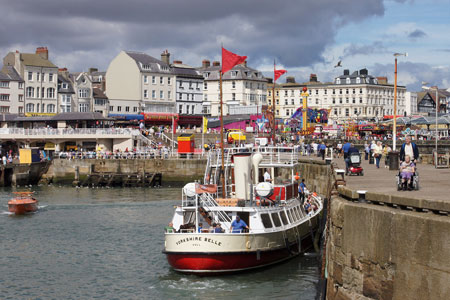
[269,69,406,122]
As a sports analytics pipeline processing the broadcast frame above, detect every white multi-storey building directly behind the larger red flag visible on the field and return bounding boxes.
[198,60,267,117]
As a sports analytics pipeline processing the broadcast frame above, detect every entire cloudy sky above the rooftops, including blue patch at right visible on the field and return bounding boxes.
[0,0,450,90]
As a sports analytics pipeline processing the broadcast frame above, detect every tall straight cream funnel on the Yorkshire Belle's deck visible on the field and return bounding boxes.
[233,153,251,199]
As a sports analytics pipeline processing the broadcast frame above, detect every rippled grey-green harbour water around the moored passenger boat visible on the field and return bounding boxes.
[0,186,319,300]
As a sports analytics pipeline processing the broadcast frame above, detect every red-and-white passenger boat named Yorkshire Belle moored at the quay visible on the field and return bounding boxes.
[163,147,323,274]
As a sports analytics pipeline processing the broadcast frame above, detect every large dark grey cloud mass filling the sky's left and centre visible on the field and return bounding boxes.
[0,0,384,71]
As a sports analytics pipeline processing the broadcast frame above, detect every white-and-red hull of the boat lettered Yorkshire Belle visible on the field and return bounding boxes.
[164,216,318,274]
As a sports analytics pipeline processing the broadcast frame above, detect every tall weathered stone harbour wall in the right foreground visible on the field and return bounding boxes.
[327,193,450,300]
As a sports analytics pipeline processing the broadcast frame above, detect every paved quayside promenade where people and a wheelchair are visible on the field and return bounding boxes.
[333,157,450,202]
